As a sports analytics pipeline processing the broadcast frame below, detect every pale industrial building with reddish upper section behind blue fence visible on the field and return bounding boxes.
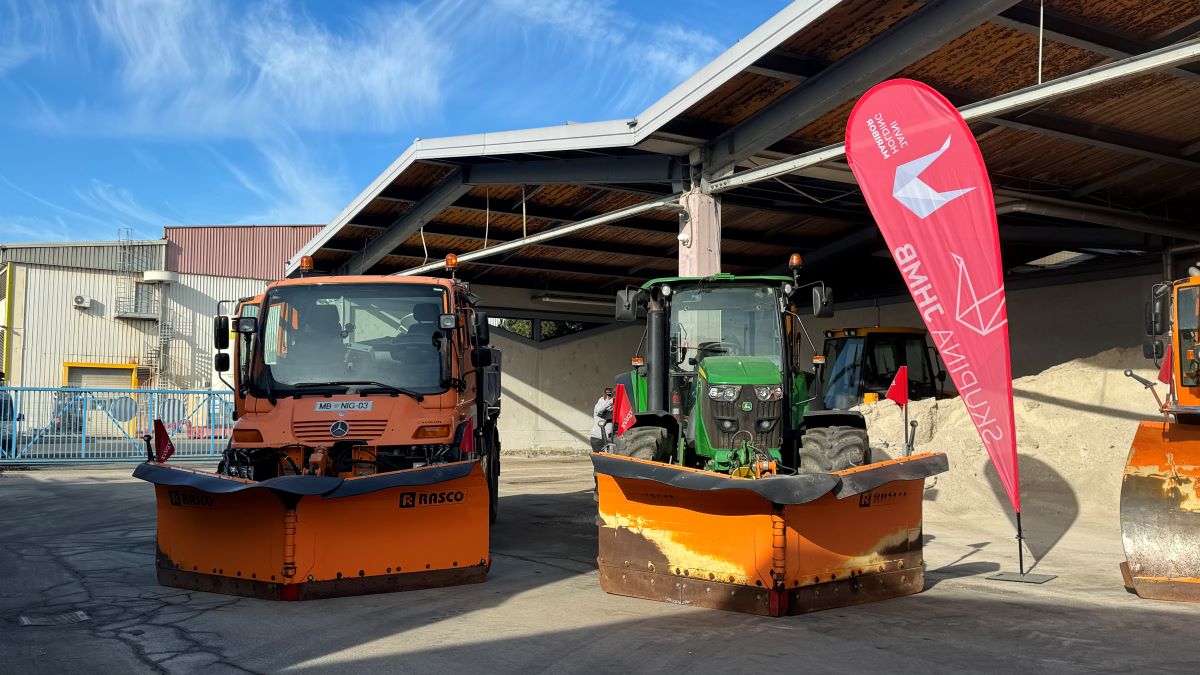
[0,226,319,390]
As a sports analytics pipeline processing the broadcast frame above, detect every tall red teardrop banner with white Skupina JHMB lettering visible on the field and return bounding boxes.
[846,79,1021,512]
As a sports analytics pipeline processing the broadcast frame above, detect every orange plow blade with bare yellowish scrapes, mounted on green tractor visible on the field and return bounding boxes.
[592,453,949,616]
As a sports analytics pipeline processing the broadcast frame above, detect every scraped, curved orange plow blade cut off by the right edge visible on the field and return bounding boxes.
[1121,420,1200,602]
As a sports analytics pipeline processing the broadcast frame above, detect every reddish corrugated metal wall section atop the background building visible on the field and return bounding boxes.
[163,225,322,281]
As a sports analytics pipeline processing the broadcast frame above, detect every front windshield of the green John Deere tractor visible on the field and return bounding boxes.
[671,286,784,372]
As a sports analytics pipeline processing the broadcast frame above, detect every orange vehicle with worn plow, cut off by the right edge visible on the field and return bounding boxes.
[1121,276,1200,602]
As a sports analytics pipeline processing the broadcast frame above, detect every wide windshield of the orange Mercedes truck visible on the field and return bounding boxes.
[251,283,445,396]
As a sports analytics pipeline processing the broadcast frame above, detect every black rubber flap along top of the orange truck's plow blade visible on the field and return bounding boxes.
[133,461,474,500]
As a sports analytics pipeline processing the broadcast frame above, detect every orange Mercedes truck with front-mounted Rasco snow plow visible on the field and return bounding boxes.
[134,270,500,599]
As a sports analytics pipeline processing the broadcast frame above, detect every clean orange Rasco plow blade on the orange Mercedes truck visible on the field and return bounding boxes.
[133,461,491,601]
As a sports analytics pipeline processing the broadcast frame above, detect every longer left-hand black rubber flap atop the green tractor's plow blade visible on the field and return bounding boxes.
[592,454,838,504]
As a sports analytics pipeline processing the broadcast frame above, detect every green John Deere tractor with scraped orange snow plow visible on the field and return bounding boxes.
[592,256,948,616]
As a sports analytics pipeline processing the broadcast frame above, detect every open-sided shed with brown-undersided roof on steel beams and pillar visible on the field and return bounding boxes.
[288,0,1200,449]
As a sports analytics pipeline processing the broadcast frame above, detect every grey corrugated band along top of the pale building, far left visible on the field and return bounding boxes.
[0,240,164,271]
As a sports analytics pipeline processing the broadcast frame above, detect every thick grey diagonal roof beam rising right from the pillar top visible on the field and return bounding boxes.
[704,0,1016,180]
